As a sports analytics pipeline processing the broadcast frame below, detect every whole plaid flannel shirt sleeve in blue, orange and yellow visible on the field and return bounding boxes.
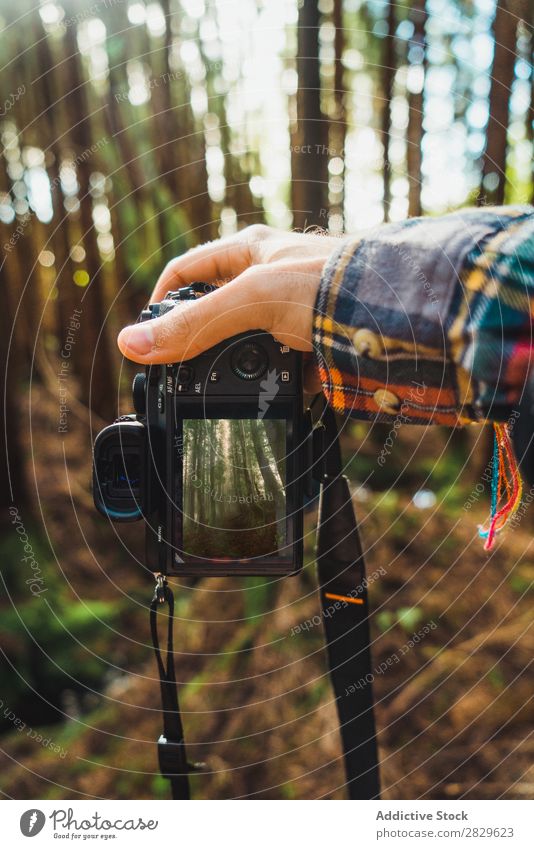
[313,206,534,426]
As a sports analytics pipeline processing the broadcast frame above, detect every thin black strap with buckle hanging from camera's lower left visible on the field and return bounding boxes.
[150,574,203,799]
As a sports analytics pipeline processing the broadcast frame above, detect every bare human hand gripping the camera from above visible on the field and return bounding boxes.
[118,224,339,380]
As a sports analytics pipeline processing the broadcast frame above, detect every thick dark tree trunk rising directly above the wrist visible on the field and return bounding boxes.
[291,0,328,228]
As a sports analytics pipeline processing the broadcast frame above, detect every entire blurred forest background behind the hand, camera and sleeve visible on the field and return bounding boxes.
[0,0,534,799]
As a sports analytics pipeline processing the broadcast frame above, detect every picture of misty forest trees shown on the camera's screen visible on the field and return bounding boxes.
[183,419,288,560]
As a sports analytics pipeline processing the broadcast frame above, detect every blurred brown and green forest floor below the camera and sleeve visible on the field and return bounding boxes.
[0,389,534,799]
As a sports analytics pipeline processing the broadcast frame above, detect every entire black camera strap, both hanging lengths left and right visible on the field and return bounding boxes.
[150,407,380,799]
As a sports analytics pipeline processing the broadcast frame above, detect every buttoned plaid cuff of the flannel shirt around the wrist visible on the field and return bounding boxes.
[313,209,524,426]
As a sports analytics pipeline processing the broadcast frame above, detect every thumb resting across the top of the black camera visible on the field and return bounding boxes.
[117,269,272,363]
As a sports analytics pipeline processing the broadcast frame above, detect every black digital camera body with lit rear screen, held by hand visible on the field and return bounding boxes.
[93,283,309,576]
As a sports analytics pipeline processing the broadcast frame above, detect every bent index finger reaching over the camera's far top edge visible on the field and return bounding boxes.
[150,232,258,303]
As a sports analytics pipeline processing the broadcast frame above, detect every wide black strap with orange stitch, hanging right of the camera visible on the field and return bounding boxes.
[317,406,380,799]
